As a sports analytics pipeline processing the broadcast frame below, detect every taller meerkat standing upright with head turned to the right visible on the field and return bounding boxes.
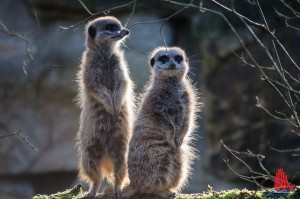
[77,16,133,198]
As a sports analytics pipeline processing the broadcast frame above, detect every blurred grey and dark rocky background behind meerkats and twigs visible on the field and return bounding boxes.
[0,0,300,199]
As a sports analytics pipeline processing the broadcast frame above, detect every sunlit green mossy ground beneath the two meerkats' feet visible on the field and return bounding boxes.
[33,185,300,199]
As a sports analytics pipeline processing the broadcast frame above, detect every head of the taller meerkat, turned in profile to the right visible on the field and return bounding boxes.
[86,16,129,47]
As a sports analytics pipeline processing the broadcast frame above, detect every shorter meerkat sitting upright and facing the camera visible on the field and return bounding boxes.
[122,47,199,198]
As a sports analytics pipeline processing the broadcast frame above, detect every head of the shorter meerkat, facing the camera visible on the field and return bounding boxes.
[150,46,189,78]
